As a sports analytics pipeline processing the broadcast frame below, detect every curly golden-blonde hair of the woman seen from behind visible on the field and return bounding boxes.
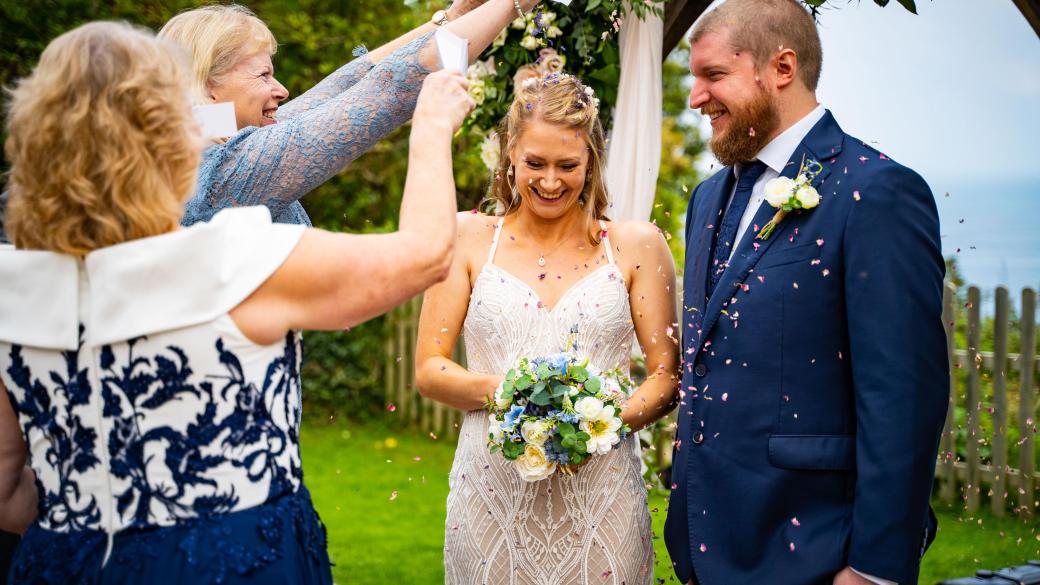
[4,22,200,256]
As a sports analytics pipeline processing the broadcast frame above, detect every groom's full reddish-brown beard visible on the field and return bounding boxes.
[708,92,780,167]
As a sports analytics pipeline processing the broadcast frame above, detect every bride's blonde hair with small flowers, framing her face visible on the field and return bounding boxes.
[485,73,608,245]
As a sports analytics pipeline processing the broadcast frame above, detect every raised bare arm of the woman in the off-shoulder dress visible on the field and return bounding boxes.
[231,72,474,344]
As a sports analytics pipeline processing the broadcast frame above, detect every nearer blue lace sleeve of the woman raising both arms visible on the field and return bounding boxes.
[182,33,433,225]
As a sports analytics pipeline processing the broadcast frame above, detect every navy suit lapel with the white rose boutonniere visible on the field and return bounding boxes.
[695,111,844,352]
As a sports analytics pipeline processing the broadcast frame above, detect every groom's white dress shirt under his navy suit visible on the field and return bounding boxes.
[726,104,898,585]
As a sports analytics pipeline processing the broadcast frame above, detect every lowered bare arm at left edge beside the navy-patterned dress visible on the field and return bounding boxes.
[0,382,36,534]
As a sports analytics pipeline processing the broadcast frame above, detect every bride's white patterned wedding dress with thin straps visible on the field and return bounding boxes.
[444,221,653,585]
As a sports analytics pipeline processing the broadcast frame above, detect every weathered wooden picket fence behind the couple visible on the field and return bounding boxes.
[384,285,1040,516]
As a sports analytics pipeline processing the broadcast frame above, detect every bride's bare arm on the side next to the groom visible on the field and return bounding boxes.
[615,222,679,431]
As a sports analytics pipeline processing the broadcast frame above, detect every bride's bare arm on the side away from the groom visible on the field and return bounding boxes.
[415,212,502,410]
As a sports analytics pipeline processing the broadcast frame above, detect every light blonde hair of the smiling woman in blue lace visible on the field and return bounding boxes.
[159,4,278,103]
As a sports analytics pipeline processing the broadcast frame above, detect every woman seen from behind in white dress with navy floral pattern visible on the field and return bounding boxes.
[0,23,473,584]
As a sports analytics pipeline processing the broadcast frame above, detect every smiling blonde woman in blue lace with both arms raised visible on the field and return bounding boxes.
[159,0,539,225]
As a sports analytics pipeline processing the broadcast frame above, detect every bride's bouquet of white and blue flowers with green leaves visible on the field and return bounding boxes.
[488,353,632,482]
